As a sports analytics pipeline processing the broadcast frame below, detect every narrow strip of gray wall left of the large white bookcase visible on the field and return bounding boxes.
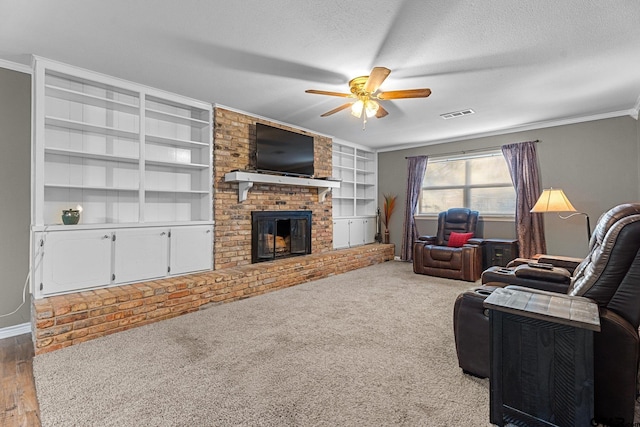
[0,68,31,328]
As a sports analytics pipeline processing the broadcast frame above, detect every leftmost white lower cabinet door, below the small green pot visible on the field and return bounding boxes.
[36,230,112,295]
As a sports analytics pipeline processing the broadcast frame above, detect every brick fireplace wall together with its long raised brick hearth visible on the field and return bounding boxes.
[32,107,394,354]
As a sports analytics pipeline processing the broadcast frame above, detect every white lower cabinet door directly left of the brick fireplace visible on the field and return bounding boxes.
[170,225,213,275]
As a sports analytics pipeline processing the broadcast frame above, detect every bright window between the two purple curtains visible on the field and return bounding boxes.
[418,151,516,216]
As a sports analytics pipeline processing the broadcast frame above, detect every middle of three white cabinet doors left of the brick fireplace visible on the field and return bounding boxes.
[114,227,169,283]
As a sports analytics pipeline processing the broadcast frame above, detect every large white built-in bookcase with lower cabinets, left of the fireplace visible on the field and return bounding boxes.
[32,58,213,296]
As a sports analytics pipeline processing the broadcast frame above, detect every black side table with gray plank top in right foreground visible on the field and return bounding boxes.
[484,286,600,427]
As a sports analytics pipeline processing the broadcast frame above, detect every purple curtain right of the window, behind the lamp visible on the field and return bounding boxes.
[502,141,547,258]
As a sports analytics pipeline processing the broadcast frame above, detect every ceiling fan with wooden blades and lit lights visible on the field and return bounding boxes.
[305,67,431,130]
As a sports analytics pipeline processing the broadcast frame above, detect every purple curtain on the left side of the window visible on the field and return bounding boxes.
[400,156,428,261]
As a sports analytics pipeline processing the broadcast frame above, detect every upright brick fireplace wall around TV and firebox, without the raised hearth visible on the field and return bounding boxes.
[213,107,333,269]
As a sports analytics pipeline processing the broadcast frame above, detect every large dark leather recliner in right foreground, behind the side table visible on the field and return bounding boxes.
[454,203,640,425]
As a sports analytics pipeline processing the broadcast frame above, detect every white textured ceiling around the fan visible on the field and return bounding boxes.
[0,0,640,148]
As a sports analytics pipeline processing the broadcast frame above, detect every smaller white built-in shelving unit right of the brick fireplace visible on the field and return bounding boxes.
[332,141,377,248]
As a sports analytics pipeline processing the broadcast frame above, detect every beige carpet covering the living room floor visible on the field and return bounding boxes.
[34,261,491,427]
